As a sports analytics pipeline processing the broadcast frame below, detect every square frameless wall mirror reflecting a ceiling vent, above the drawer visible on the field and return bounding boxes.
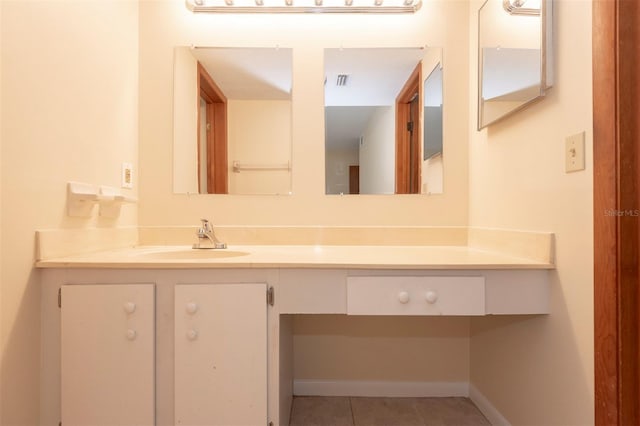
[324,47,443,194]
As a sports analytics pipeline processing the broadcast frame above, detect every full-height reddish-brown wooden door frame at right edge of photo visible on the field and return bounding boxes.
[593,0,640,425]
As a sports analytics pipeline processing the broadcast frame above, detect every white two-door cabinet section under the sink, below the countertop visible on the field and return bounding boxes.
[46,269,269,426]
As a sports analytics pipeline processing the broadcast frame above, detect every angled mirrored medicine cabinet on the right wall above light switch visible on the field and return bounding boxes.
[478,0,553,130]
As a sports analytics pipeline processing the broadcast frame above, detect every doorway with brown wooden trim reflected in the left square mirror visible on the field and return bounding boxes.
[198,63,228,194]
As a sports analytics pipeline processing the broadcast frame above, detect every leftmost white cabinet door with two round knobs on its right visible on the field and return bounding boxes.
[61,284,155,426]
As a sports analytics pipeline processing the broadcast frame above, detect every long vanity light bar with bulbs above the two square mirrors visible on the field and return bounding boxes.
[186,0,420,13]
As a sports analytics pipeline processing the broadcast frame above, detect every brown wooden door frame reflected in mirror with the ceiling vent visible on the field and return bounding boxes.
[396,61,422,194]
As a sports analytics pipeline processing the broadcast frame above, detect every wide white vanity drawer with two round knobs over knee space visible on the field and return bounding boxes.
[347,276,485,315]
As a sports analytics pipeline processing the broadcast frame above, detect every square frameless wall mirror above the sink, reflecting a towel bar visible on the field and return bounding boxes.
[173,47,292,194]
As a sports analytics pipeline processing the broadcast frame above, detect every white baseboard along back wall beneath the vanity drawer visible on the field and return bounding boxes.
[293,379,469,397]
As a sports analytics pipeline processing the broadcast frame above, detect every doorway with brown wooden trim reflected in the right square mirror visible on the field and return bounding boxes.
[396,62,422,194]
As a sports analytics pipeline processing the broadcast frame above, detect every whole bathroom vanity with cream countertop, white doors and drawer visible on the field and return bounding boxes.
[37,240,553,425]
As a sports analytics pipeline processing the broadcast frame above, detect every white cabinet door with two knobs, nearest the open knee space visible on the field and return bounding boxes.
[175,284,267,426]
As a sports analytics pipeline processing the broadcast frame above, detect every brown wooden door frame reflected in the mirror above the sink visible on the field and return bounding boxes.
[197,62,229,194]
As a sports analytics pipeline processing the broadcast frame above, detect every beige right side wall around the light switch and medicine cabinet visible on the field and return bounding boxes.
[464,0,594,425]
